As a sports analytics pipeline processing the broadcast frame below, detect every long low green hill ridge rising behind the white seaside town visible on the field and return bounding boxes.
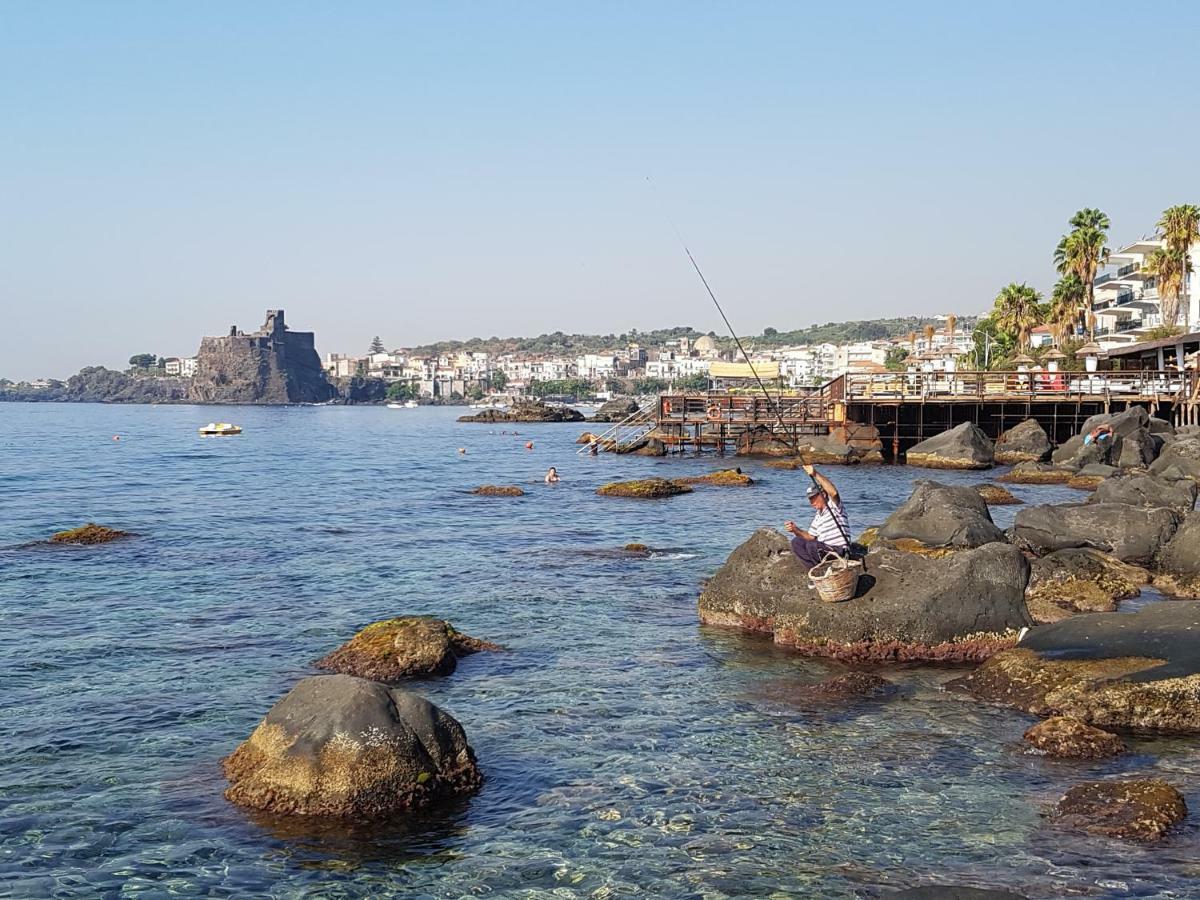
[412,316,976,355]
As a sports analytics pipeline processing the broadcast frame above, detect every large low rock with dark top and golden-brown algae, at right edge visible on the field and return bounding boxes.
[954,600,1200,734]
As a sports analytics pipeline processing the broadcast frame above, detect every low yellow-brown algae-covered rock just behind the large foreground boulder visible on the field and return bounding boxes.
[316,616,500,682]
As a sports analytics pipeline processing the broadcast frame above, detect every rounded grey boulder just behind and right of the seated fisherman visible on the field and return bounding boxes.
[878,480,1004,550]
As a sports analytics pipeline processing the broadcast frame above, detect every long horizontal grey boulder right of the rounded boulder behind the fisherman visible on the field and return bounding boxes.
[1013,503,1180,565]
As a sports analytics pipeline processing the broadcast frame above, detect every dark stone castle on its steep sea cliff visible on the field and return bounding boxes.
[188,310,336,403]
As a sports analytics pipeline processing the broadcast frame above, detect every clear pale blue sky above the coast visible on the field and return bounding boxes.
[0,0,1200,379]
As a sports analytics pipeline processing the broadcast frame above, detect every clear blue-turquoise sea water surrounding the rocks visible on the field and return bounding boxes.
[0,403,1200,898]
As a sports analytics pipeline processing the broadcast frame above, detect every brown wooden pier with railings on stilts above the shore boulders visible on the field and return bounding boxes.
[642,371,1200,457]
